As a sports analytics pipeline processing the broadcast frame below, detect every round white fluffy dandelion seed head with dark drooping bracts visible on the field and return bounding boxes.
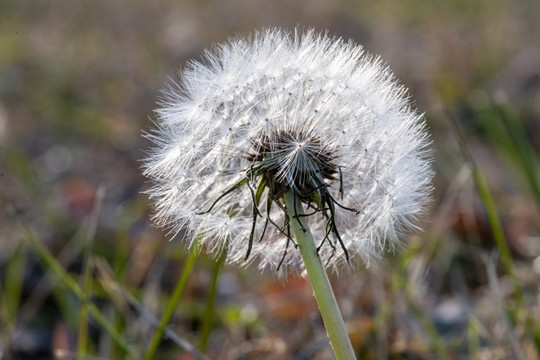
[144,29,432,274]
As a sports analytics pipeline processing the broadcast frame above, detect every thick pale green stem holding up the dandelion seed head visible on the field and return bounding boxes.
[284,191,356,360]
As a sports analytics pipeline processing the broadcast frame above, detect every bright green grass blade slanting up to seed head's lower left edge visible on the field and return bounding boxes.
[144,245,199,360]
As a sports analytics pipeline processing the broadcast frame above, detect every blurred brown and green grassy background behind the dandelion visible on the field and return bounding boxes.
[0,0,540,359]
